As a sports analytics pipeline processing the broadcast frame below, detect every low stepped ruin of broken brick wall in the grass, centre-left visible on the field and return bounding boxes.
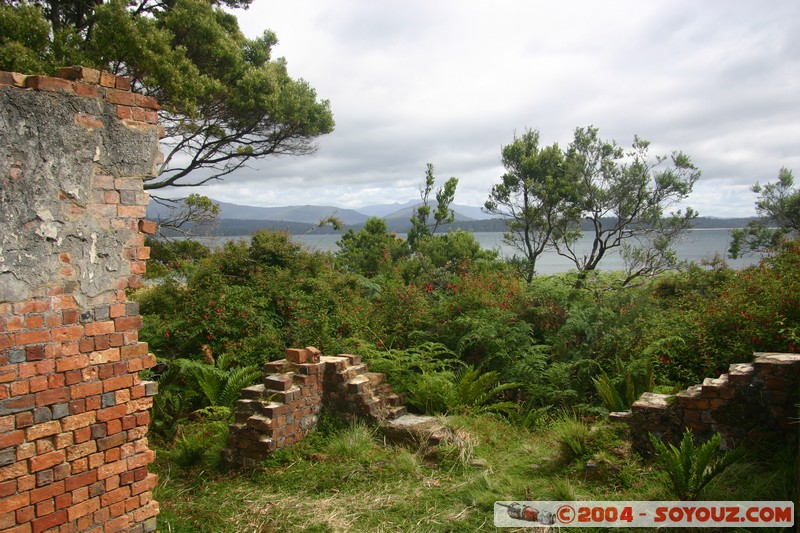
[223,347,406,466]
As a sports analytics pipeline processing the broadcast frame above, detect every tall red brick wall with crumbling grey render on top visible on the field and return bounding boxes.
[0,67,160,533]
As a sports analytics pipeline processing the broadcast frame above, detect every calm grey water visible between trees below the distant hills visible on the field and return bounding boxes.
[198,229,758,274]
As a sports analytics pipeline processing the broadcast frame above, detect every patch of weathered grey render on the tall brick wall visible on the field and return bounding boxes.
[0,88,159,304]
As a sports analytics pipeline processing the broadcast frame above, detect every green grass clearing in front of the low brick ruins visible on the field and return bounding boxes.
[154,414,797,533]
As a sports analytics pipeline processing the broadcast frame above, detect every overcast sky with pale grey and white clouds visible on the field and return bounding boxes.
[189,0,800,216]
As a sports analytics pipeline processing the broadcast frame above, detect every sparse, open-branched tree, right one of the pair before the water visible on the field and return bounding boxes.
[552,126,700,286]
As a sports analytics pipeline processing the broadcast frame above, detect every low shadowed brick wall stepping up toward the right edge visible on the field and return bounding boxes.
[624,353,800,455]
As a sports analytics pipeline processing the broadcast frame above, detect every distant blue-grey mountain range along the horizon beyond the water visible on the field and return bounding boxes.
[147,200,751,235]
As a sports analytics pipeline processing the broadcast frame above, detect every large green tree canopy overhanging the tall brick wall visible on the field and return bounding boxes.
[0,0,334,189]
